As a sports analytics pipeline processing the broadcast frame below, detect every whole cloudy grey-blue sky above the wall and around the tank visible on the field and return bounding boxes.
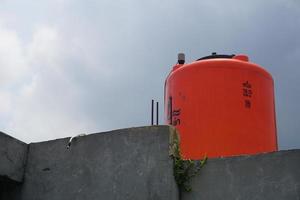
[0,0,300,149]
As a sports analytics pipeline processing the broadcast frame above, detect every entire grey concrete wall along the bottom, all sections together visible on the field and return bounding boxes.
[0,126,300,200]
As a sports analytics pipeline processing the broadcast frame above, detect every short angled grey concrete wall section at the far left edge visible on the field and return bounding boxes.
[0,132,28,182]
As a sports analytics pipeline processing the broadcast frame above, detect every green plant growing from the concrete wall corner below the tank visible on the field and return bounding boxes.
[170,130,207,192]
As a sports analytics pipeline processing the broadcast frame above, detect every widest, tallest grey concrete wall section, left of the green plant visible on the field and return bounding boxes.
[22,126,178,200]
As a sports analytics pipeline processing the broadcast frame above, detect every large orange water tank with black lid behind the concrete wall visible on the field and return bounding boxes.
[165,53,278,159]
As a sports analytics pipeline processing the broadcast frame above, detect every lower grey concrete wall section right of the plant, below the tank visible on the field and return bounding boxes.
[182,150,300,200]
